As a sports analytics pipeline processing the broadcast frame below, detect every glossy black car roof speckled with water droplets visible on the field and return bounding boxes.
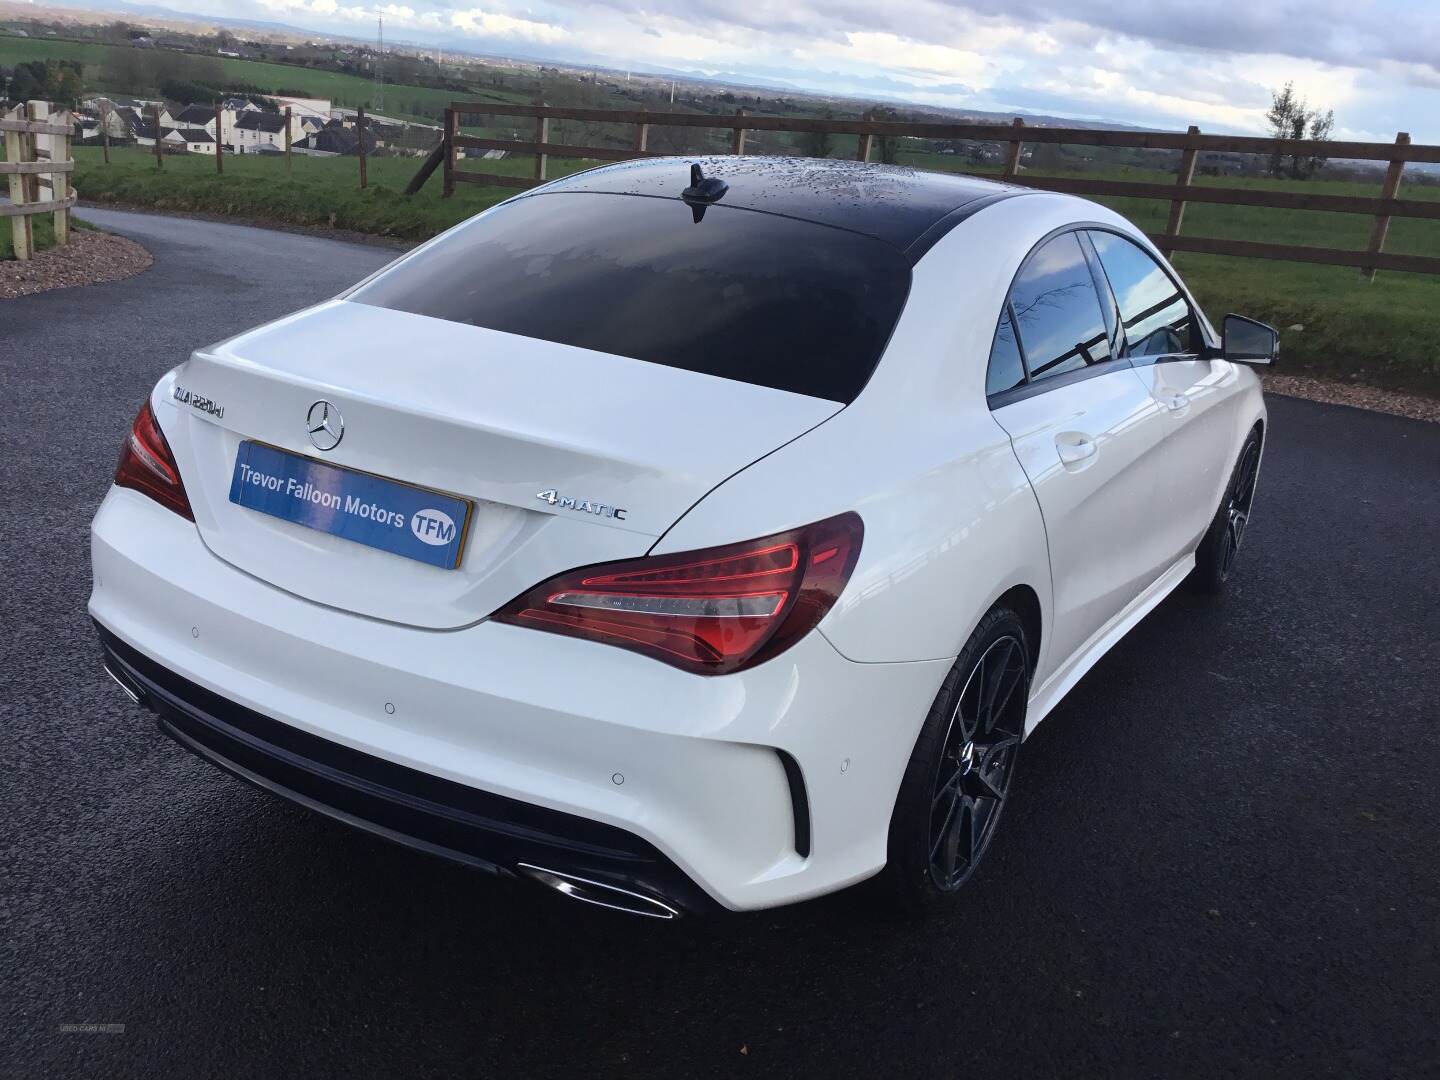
[536,157,1028,262]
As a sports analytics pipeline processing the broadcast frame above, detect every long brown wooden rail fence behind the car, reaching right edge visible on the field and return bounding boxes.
[406,101,1440,279]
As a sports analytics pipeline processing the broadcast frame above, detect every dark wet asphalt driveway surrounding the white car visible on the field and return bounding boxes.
[0,210,1440,1077]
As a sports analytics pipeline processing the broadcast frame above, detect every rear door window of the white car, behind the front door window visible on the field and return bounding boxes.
[1009,233,1110,380]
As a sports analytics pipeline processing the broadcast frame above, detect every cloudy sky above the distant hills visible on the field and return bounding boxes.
[61,0,1440,143]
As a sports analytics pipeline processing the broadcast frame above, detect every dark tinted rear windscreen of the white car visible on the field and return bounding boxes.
[348,192,910,403]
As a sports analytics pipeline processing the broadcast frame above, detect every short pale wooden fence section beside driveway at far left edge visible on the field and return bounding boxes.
[0,101,75,259]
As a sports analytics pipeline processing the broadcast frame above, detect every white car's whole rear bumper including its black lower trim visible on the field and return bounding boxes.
[89,490,949,910]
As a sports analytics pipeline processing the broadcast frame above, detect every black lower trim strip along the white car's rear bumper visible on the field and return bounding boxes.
[95,622,719,912]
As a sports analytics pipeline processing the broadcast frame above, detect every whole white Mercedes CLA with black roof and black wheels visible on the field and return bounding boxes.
[89,157,1277,917]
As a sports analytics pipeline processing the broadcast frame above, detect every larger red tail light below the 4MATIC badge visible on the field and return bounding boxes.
[492,513,864,675]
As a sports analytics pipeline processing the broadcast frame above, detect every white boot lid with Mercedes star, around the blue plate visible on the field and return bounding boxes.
[161,301,842,629]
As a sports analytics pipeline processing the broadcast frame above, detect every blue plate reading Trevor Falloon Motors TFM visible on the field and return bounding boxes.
[230,439,472,570]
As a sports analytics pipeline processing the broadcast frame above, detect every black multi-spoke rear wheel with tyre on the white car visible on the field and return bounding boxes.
[877,608,1031,914]
